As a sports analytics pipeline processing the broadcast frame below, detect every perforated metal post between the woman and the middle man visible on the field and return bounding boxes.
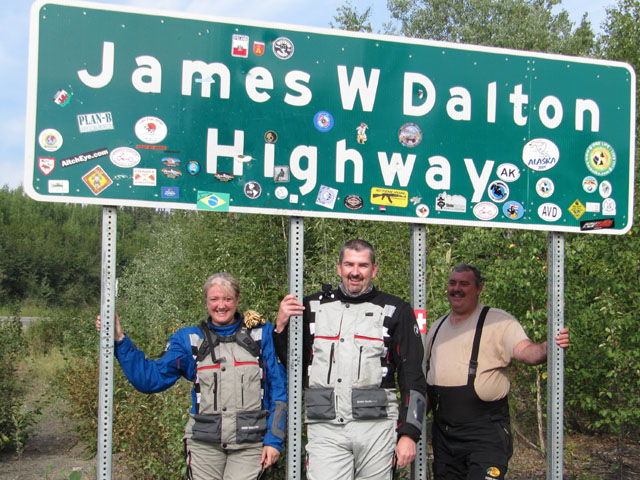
[287,217,304,479]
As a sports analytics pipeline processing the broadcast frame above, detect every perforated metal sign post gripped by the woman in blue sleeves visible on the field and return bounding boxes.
[97,207,117,480]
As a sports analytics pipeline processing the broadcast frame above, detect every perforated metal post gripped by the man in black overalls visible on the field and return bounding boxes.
[547,232,564,480]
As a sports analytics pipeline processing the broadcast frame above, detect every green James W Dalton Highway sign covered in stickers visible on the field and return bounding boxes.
[24,1,636,234]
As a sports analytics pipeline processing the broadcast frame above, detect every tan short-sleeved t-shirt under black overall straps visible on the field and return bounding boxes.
[426,304,529,402]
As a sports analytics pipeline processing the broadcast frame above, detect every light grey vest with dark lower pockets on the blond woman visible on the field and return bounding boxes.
[185,322,268,449]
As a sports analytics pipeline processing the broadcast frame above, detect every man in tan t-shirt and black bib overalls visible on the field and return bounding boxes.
[426,264,569,480]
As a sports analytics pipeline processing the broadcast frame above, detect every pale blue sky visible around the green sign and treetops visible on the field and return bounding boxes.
[0,0,615,189]
